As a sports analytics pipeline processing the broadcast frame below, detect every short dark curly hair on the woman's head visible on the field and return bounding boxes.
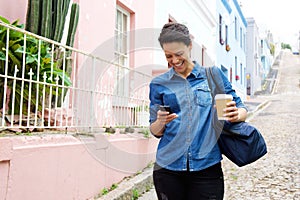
[158,22,191,47]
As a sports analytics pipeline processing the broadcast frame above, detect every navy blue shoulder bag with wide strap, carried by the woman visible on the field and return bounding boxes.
[205,67,267,167]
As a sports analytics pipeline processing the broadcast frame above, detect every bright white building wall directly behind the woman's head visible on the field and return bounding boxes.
[154,0,216,67]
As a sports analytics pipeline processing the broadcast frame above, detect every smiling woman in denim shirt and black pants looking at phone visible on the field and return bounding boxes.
[149,23,247,200]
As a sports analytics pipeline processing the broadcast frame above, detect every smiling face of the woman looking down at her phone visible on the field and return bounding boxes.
[163,42,194,77]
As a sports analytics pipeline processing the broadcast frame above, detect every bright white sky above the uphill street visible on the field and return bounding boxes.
[238,0,300,46]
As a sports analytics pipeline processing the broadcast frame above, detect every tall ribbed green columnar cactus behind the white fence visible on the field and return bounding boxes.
[25,0,79,108]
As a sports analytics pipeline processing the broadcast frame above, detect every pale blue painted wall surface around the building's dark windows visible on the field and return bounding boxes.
[215,0,246,99]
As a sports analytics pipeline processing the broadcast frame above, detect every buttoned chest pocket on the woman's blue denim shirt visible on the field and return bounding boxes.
[194,85,212,106]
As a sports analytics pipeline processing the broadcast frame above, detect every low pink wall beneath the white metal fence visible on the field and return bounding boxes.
[0,134,157,200]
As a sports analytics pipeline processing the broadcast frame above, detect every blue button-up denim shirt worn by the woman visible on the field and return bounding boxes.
[149,62,245,171]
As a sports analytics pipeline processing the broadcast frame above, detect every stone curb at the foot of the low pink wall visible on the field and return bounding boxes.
[95,167,153,200]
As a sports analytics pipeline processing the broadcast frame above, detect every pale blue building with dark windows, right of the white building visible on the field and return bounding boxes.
[215,0,247,99]
